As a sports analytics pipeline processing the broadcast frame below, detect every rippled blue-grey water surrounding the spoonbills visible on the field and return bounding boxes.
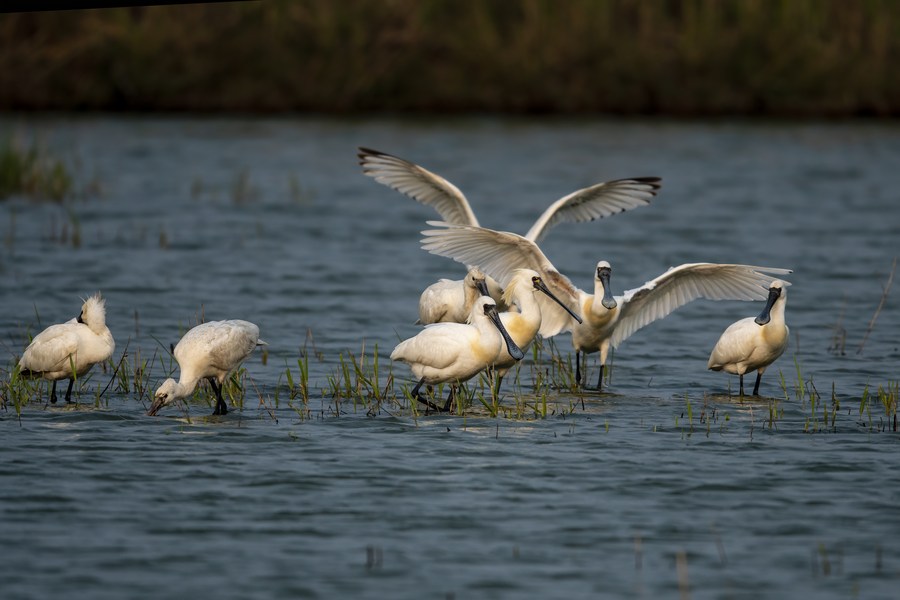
[0,117,900,598]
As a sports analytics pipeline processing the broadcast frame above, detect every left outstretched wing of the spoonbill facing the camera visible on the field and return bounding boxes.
[422,221,581,336]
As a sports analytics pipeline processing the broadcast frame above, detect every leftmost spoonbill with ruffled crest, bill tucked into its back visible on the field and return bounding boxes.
[19,292,116,403]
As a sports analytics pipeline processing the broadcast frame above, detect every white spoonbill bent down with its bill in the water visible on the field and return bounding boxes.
[147,320,266,416]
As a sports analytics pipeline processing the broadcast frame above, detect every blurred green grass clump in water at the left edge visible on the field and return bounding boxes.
[0,140,74,202]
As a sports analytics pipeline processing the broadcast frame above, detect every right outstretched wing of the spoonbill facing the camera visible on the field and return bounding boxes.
[610,263,792,348]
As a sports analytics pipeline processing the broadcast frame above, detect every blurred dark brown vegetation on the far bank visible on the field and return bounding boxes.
[0,0,900,116]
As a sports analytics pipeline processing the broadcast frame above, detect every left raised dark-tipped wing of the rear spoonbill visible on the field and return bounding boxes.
[357,148,478,227]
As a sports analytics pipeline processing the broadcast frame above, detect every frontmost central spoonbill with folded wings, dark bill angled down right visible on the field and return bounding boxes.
[391,296,525,412]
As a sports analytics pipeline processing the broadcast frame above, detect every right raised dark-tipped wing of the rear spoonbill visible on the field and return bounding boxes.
[525,177,662,242]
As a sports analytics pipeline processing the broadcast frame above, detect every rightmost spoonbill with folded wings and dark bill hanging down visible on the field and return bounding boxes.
[706,279,790,396]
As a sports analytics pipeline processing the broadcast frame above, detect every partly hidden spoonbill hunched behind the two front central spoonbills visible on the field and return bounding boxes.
[416,267,503,325]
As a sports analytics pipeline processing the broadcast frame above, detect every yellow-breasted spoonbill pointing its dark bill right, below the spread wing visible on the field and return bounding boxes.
[494,269,581,391]
